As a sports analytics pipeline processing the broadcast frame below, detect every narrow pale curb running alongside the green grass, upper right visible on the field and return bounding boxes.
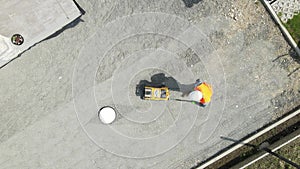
[261,0,300,57]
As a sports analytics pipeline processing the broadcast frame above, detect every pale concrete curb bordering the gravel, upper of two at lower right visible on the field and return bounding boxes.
[197,109,300,169]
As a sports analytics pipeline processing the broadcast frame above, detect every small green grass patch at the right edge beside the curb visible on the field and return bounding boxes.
[284,14,300,46]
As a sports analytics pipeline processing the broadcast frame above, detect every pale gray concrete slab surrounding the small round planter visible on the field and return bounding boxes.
[0,0,81,67]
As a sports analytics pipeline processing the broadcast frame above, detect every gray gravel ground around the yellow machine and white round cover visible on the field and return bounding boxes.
[0,0,300,169]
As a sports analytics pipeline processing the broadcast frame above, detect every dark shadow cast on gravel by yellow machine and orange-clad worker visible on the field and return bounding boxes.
[135,73,194,98]
